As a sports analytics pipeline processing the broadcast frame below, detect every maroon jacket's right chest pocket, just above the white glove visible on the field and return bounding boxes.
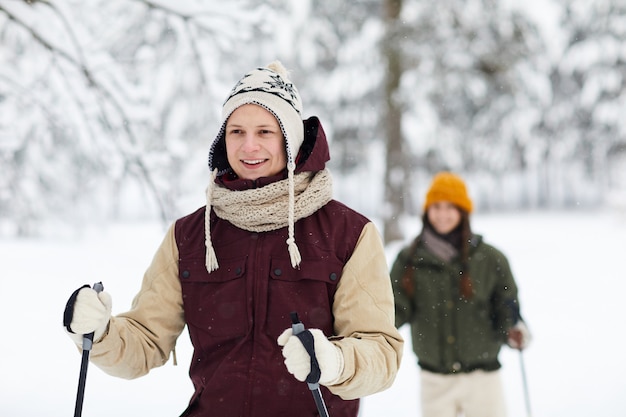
[266,258,343,337]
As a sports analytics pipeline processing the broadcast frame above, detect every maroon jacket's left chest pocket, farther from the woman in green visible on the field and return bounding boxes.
[179,257,248,338]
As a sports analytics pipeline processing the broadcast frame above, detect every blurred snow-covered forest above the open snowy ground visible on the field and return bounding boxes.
[0,0,626,242]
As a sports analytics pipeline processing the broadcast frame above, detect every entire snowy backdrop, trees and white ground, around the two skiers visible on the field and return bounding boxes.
[0,0,626,417]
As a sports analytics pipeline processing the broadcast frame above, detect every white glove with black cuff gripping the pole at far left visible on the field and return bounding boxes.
[63,285,112,345]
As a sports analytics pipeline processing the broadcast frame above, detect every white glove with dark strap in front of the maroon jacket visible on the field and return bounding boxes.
[277,329,344,385]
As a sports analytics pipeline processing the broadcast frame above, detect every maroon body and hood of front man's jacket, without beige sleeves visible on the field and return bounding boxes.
[176,115,360,417]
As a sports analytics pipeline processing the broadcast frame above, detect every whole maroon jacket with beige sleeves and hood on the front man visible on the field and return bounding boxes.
[86,118,403,417]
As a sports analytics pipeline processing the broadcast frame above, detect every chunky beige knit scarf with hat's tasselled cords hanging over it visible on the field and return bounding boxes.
[205,169,332,272]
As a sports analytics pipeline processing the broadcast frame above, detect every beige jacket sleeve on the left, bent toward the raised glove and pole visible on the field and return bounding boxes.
[90,225,185,379]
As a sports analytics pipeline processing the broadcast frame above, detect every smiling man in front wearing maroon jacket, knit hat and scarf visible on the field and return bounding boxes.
[66,62,403,417]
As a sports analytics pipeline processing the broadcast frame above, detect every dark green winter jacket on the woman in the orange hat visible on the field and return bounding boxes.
[391,235,519,374]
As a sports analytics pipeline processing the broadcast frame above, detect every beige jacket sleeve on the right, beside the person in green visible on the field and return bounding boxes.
[328,223,404,400]
